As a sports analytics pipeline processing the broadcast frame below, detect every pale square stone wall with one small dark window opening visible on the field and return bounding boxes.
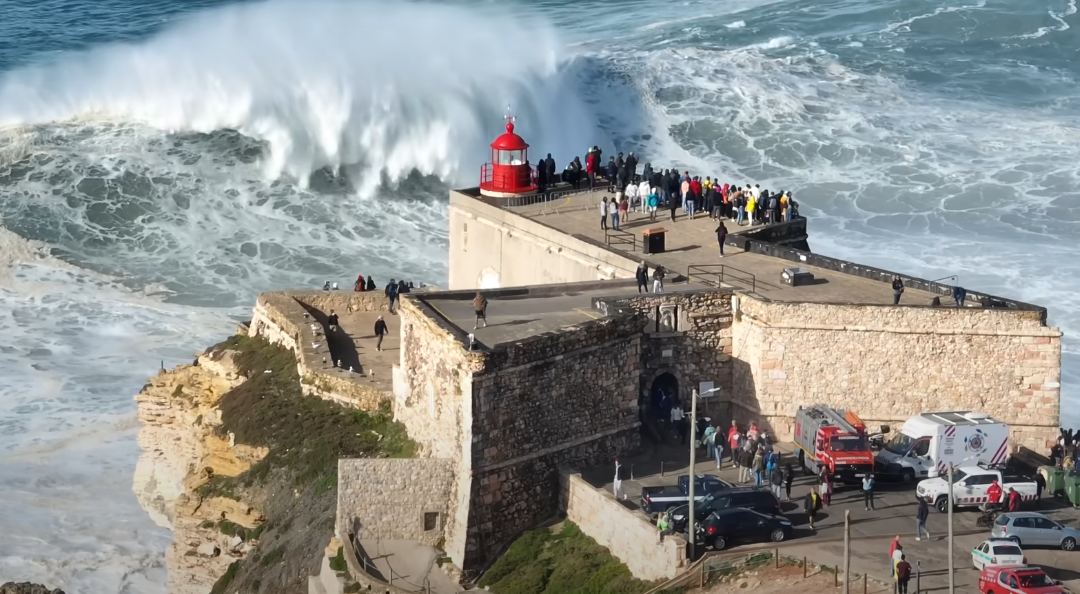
[337,458,457,548]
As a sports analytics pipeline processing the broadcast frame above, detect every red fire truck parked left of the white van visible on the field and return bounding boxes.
[795,404,874,484]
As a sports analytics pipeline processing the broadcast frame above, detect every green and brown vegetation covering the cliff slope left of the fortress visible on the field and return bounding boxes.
[199,336,416,593]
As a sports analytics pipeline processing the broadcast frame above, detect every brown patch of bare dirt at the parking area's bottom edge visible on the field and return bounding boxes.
[689,565,893,594]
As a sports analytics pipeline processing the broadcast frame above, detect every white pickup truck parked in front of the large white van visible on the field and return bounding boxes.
[915,464,1037,513]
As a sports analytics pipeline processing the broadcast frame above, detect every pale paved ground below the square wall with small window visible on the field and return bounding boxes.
[357,540,461,594]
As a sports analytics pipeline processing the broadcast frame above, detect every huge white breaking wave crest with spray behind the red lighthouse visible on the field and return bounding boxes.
[0,0,598,193]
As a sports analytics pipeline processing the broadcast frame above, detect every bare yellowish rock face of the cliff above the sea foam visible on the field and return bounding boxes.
[133,351,268,594]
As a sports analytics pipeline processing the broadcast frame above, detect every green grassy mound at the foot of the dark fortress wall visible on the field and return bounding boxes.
[480,522,657,594]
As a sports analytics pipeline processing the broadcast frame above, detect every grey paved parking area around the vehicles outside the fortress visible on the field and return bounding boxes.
[582,444,1080,593]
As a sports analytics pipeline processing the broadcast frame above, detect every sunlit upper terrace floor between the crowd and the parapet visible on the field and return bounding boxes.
[509,191,948,306]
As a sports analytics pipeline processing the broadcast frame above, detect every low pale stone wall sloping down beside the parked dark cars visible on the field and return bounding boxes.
[561,470,686,581]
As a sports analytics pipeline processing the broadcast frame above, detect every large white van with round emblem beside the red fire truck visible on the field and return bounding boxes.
[874,410,1010,483]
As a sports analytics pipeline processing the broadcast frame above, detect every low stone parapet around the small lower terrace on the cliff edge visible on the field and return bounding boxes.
[248,291,387,410]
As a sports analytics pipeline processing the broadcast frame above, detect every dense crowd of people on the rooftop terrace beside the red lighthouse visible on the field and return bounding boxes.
[537,146,798,229]
